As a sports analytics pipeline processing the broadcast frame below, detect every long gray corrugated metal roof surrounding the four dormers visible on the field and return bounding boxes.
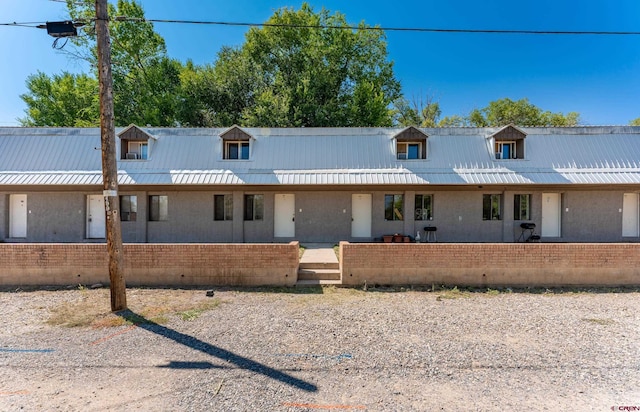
[0,126,640,185]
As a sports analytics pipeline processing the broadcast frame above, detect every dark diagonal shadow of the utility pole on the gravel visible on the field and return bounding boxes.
[117,309,318,392]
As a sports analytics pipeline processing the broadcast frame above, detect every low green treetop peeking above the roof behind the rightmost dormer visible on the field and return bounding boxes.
[468,98,580,127]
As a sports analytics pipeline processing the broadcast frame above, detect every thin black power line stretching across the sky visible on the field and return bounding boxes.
[0,16,640,36]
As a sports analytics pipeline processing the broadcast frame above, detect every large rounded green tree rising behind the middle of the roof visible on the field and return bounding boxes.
[236,3,400,127]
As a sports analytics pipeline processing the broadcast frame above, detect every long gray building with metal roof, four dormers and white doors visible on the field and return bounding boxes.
[0,125,640,243]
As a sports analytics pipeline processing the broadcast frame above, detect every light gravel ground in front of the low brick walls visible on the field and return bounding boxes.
[0,288,640,411]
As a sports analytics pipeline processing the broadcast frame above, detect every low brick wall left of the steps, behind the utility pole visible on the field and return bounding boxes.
[0,242,299,286]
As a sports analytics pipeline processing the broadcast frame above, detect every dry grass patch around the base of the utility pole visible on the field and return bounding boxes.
[47,289,223,328]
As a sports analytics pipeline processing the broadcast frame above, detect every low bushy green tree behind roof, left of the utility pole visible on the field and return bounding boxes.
[19,72,100,127]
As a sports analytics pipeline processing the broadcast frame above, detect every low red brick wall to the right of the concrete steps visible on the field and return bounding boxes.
[340,242,640,286]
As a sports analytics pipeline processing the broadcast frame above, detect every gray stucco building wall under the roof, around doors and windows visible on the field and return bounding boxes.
[0,185,640,243]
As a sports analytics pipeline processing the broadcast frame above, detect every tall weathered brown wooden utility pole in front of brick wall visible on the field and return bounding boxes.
[96,0,127,312]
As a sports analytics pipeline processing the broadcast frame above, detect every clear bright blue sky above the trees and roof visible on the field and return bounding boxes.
[0,0,640,126]
